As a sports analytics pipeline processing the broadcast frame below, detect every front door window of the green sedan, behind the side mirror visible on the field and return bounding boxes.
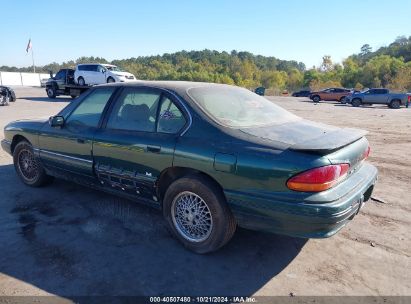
[66,87,115,128]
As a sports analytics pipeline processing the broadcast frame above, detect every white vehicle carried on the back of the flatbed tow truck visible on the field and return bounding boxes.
[74,63,136,85]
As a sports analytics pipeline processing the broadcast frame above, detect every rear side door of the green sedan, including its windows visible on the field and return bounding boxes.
[93,87,187,203]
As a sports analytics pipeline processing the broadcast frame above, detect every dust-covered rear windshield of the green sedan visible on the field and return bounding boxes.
[187,85,301,128]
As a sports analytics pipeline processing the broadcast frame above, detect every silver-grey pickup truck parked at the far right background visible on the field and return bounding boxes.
[345,88,408,109]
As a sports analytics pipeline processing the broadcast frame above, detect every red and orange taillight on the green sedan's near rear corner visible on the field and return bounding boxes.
[287,164,350,192]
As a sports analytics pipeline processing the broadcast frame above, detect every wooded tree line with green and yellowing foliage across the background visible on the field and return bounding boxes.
[0,36,411,92]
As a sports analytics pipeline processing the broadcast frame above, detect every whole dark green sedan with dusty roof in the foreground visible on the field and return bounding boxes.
[1,81,377,253]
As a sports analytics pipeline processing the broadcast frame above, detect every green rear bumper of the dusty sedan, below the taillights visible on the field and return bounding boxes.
[225,163,378,238]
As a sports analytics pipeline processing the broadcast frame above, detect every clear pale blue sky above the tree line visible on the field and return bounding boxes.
[0,0,411,67]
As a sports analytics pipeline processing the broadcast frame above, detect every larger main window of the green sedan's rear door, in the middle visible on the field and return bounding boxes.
[107,88,161,132]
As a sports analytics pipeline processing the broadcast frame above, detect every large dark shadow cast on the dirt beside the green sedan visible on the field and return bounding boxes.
[0,165,306,299]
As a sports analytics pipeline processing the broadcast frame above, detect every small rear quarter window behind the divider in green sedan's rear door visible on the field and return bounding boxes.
[157,97,186,134]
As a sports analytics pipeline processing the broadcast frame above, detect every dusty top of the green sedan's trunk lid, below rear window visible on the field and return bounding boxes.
[241,119,367,154]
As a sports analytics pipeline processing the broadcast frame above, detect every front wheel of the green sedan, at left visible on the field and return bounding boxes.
[13,140,53,187]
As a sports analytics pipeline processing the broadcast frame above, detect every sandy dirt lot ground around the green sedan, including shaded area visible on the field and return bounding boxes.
[0,88,411,299]
